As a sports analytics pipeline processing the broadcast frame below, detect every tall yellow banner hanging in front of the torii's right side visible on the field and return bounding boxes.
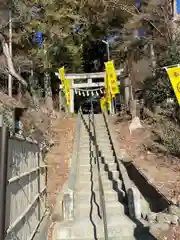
[105,61,119,97]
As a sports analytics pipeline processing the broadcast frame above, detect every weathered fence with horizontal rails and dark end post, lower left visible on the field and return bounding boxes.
[0,127,47,240]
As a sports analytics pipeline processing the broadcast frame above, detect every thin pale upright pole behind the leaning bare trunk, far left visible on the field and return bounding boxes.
[8,6,12,97]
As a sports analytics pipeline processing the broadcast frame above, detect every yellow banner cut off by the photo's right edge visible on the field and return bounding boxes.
[166,67,180,105]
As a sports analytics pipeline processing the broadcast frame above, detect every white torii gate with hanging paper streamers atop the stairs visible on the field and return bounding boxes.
[55,69,123,113]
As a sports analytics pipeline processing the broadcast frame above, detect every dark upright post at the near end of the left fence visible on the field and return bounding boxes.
[0,127,9,239]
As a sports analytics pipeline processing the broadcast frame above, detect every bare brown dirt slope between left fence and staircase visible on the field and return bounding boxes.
[46,117,76,240]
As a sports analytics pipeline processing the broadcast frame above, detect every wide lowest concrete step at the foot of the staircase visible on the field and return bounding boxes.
[54,216,135,240]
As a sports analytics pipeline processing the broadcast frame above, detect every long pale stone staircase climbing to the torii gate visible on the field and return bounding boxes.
[53,115,155,240]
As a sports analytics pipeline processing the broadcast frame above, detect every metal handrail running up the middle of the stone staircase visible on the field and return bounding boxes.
[91,101,108,240]
